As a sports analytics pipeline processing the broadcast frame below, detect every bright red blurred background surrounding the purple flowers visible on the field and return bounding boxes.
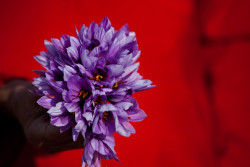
[0,0,250,167]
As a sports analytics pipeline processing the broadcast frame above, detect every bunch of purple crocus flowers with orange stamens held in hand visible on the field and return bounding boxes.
[33,17,154,167]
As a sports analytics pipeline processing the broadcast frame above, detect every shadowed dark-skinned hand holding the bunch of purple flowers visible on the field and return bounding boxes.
[0,80,83,153]
